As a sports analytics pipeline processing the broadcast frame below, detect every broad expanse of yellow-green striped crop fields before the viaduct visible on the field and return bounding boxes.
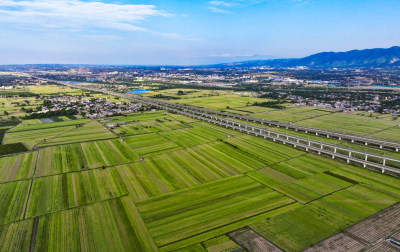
[0,109,400,252]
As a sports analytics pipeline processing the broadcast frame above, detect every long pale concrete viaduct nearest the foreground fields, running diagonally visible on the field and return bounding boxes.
[57,83,400,175]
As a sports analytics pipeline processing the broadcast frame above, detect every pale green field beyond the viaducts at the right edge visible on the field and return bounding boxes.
[297,113,399,139]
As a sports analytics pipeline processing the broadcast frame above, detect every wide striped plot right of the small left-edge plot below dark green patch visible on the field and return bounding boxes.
[36,139,139,176]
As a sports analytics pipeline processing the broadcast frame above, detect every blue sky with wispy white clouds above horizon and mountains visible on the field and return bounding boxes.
[0,0,400,65]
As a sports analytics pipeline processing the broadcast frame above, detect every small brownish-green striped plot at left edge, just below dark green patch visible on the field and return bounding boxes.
[0,152,37,183]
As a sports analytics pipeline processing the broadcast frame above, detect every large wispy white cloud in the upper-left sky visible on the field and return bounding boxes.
[0,0,171,31]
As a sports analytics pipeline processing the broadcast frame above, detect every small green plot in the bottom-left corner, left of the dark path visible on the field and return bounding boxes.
[0,219,33,251]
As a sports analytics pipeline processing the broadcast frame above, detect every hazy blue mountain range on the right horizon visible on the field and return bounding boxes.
[213,46,400,68]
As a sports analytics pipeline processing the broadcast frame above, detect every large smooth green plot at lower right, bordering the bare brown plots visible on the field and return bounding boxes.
[250,185,400,251]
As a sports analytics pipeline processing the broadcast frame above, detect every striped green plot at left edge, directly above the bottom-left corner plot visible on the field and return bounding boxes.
[0,180,31,225]
